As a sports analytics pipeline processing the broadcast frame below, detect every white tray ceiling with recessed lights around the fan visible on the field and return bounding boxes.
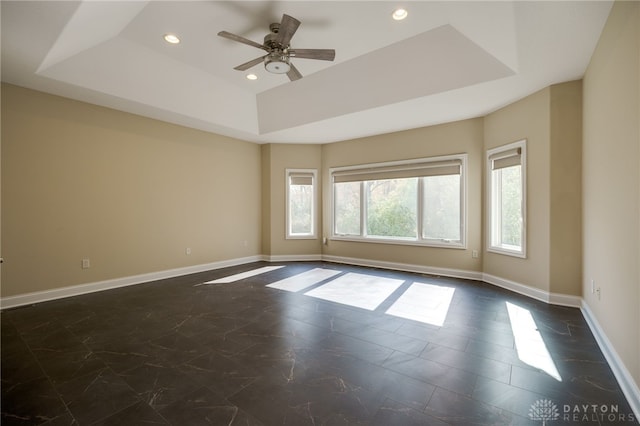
[0,0,612,143]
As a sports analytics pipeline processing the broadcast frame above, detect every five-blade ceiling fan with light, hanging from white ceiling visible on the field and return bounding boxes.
[218,14,336,81]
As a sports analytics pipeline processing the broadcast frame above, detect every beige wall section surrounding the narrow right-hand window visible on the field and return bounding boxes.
[483,88,551,291]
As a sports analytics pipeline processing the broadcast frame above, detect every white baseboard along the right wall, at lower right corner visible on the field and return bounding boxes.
[580,299,640,419]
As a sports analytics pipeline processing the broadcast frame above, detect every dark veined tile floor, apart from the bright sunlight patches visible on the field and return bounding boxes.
[1,262,634,426]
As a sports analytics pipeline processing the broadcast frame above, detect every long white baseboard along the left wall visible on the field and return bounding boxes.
[0,256,264,309]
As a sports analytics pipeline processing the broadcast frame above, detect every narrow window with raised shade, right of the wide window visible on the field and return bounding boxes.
[487,141,526,257]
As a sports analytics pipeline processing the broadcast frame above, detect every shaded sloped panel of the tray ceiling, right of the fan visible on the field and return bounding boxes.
[257,25,514,133]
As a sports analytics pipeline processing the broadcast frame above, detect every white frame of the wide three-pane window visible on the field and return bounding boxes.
[329,153,467,249]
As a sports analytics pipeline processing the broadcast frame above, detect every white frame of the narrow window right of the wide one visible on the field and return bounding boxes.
[485,139,527,258]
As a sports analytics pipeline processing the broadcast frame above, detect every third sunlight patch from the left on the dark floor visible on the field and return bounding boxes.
[305,272,404,311]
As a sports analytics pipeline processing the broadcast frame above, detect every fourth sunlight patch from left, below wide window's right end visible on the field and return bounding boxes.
[386,283,456,327]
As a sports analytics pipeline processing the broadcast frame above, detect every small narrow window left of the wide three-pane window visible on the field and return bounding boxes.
[286,169,317,239]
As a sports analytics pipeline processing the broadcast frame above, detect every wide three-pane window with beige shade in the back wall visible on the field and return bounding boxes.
[331,154,467,248]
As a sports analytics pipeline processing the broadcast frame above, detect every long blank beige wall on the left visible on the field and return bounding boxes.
[2,84,261,297]
